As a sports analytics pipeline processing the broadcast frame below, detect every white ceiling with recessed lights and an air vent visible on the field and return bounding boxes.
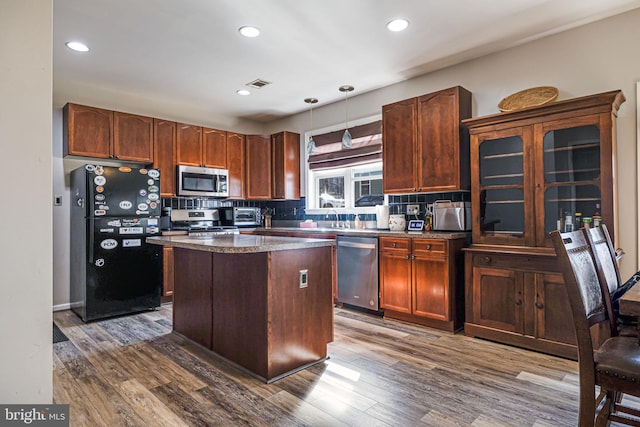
[53,0,640,122]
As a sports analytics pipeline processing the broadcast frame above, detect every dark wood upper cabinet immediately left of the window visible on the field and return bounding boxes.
[271,131,300,200]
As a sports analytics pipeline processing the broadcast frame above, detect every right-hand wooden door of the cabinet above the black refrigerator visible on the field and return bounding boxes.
[113,111,153,163]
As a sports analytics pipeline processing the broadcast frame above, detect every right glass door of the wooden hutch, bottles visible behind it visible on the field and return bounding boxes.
[536,122,602,246]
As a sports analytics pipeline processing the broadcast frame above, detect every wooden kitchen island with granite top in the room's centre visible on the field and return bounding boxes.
[147,235,335,383]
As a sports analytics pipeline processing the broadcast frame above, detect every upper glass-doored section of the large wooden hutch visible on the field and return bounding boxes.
[465,91,624,247]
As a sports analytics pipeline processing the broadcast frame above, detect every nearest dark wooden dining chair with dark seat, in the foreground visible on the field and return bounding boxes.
[551,230,640,427]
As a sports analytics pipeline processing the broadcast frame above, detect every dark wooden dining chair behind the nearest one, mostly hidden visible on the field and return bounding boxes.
[583,224,640,335]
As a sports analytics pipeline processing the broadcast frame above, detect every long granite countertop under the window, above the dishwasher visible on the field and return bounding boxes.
[245,227,471,240]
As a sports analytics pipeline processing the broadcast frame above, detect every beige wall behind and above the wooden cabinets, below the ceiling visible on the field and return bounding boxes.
[54,10,640,307]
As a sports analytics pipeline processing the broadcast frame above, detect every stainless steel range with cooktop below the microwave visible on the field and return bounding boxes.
[171,209,240,237]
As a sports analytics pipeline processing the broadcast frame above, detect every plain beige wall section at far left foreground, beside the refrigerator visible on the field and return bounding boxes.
[0,0,53,404]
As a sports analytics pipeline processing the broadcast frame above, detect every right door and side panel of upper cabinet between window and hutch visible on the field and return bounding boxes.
[418,86,471,191]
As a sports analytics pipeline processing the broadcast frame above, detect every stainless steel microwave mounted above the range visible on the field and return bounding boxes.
[177,165,229,197]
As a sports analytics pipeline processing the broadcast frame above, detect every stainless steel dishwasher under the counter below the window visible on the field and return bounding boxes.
[337,235,380,311]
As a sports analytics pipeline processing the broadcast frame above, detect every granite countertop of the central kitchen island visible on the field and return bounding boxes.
[147,234,335,254]
